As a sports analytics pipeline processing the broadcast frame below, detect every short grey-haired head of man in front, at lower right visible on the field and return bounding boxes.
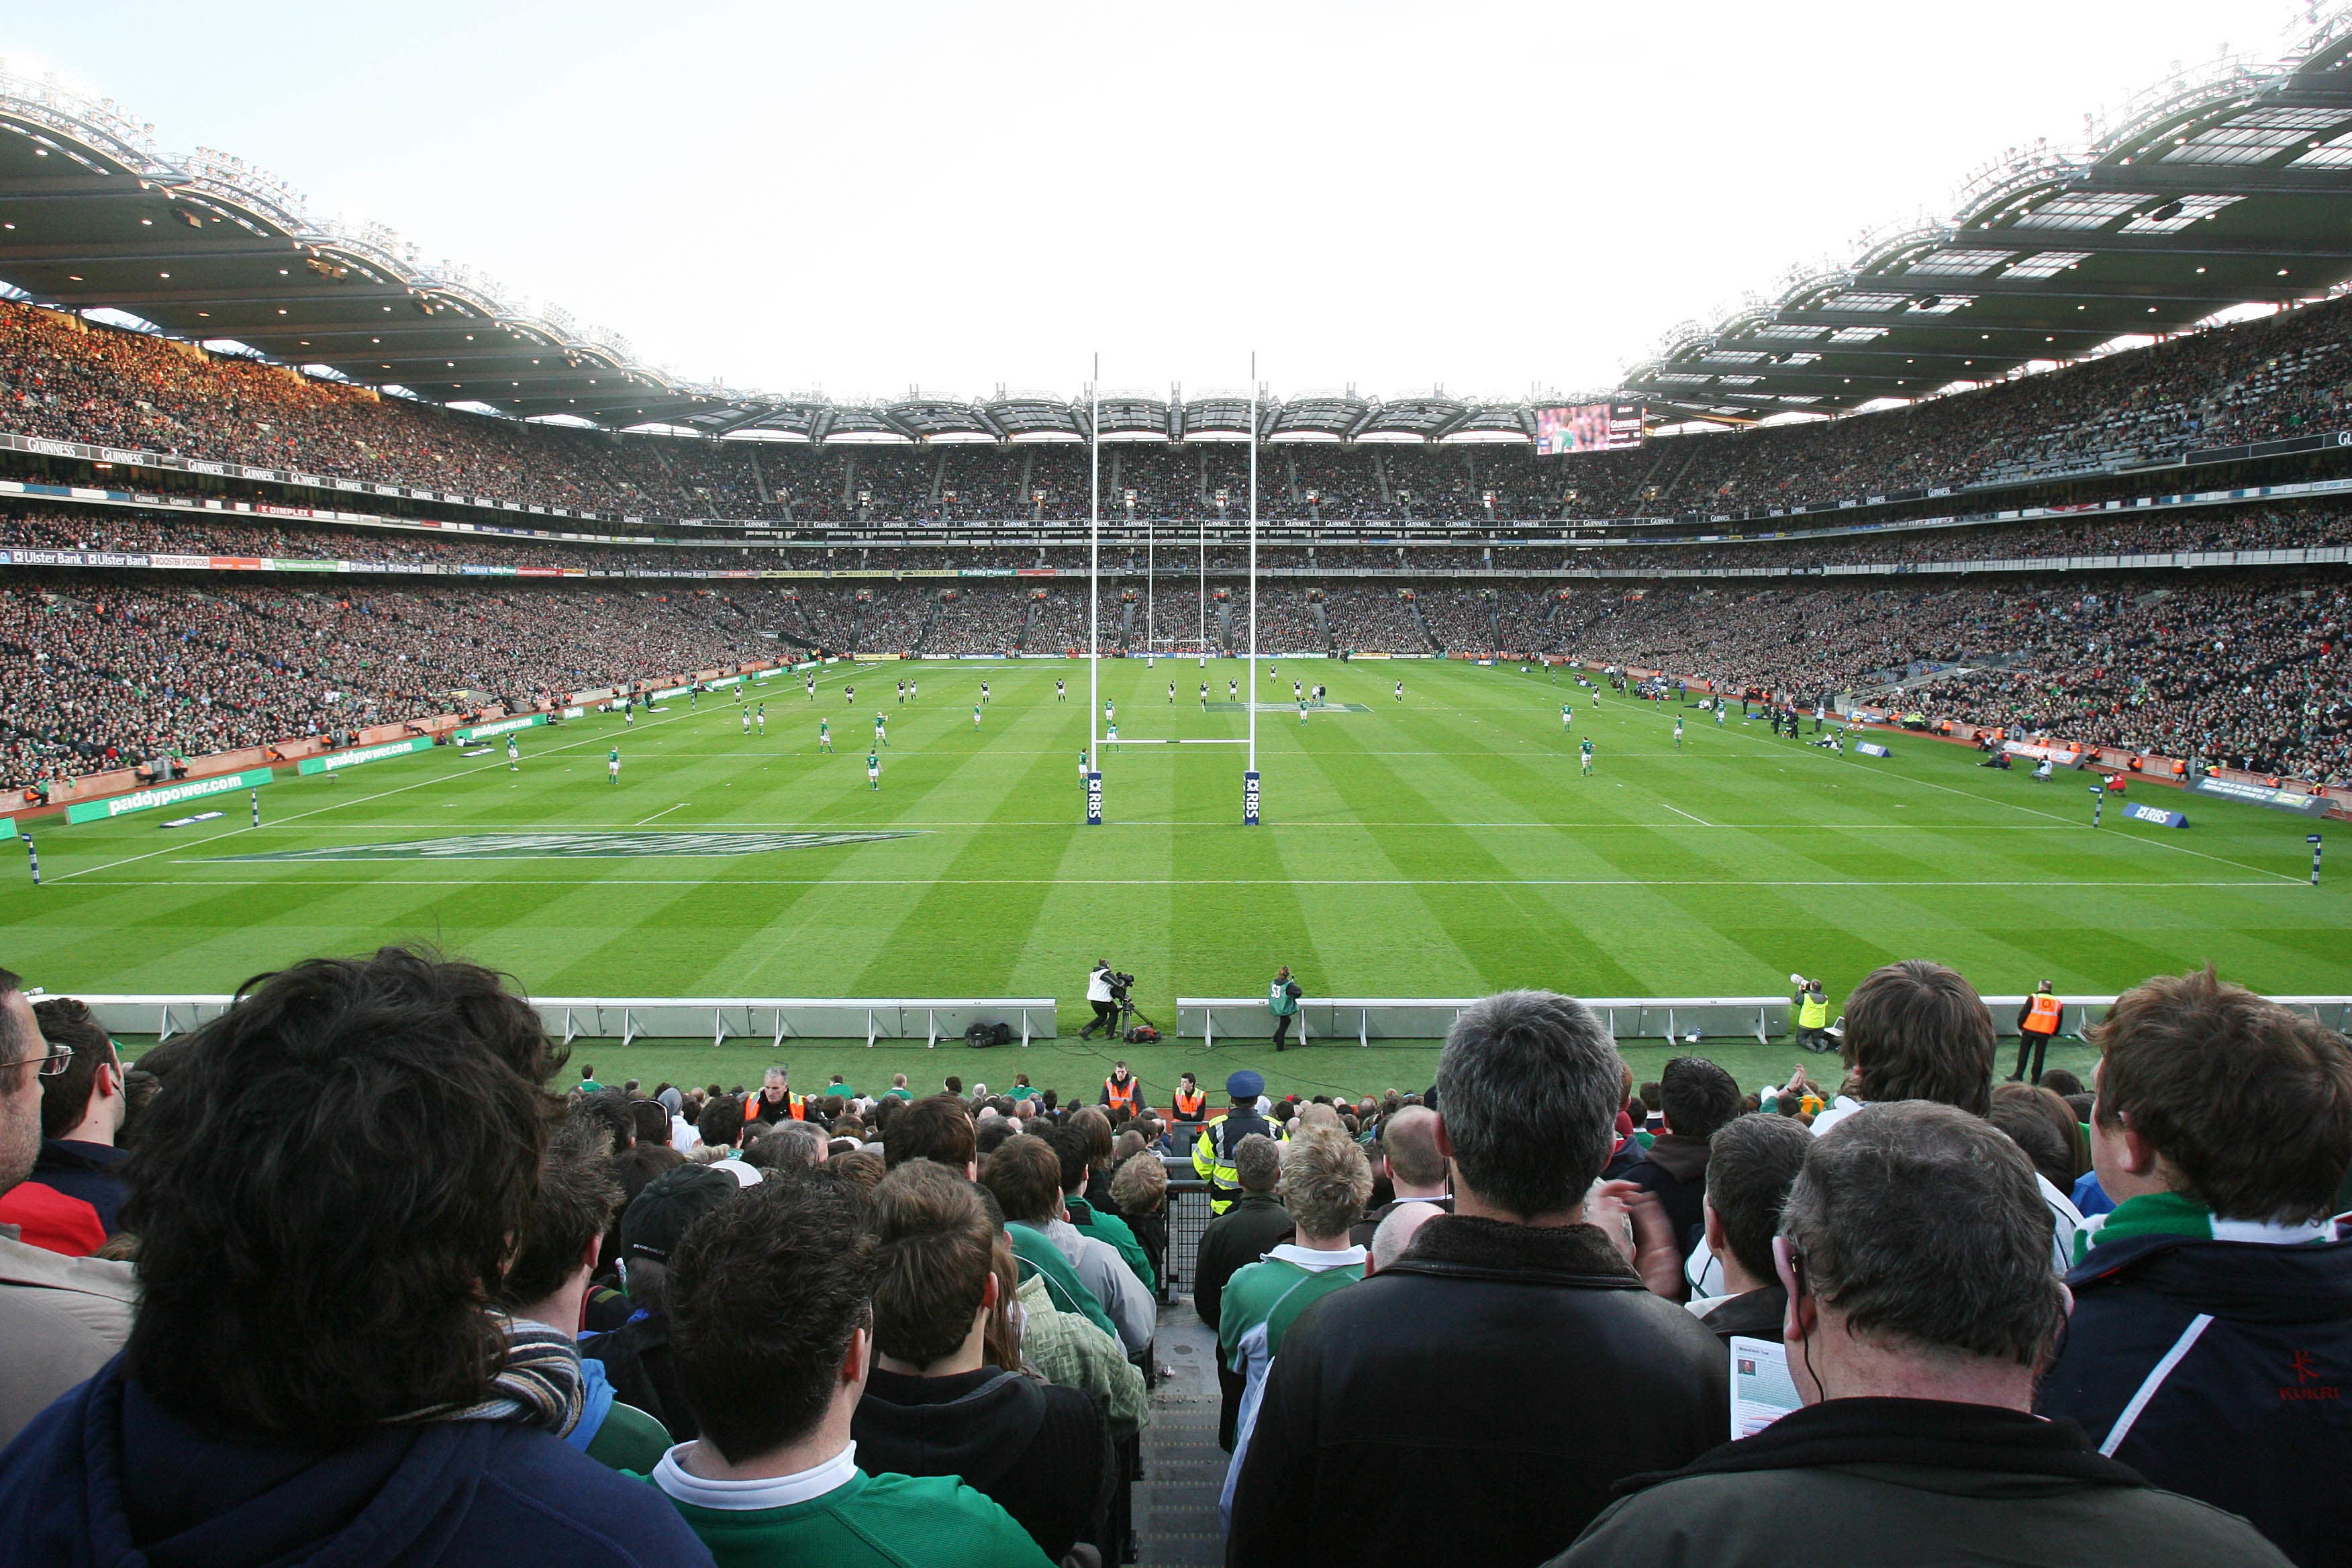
[1776,1103,2067,1408]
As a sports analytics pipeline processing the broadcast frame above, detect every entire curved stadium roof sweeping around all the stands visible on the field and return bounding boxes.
[13,0,2352,442]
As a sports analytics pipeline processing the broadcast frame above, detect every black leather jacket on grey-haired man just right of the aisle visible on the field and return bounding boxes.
[1226,1216,1728,1568]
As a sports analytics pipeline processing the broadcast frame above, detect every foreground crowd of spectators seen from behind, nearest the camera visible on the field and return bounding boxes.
[0,947,2352,1568]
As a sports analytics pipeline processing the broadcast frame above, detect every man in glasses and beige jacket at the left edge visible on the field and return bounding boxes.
[0,969,136,1443]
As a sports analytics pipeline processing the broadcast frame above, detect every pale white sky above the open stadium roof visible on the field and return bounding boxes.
[0,0,2305,399]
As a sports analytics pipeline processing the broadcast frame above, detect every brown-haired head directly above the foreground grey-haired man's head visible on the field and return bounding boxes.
[1844,959,1994,1117]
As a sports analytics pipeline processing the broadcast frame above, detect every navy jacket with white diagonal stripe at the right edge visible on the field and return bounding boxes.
[2037,1236,2352,1563]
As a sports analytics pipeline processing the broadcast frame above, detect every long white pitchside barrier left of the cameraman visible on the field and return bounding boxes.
[66,994,1056,1048]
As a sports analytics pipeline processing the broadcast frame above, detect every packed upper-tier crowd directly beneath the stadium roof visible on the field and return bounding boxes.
[13,285,2352,524]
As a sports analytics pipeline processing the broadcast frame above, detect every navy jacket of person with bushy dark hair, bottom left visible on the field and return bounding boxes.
[0,1357,710,1568]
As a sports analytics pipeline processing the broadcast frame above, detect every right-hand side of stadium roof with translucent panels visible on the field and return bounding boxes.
[1625,5,2352,418]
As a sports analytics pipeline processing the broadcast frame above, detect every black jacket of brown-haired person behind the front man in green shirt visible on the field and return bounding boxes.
[849,1366,1117,1561]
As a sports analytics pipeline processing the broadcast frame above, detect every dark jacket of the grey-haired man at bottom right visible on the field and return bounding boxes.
[1552,1401,2286,1568]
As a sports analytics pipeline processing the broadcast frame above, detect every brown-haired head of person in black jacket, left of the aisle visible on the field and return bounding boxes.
[873,1159,997,1373]
